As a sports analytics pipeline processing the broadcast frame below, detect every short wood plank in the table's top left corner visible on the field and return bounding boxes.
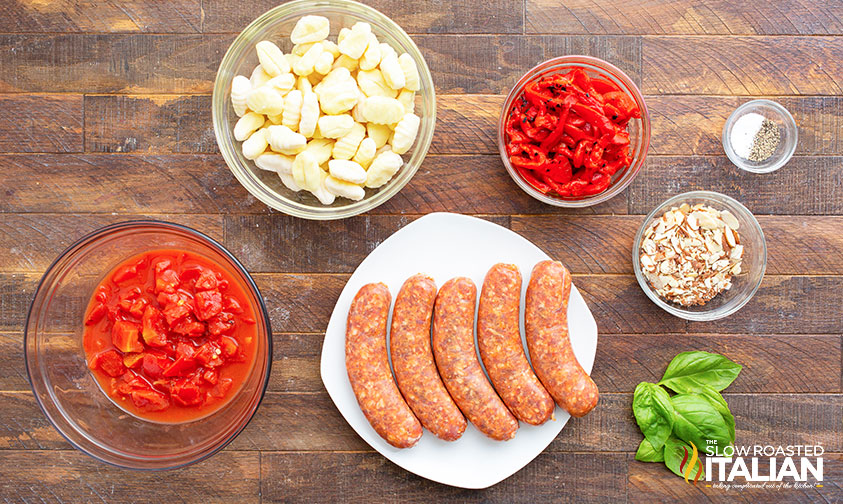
[0,0,201,33]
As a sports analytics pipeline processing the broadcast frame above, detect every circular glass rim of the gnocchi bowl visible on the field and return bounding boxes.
[211,0,436,220]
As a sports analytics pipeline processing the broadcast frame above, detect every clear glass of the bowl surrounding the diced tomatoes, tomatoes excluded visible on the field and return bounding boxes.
[24,221,272,469]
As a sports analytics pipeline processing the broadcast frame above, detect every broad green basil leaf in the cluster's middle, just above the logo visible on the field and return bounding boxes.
[670,394,732,453]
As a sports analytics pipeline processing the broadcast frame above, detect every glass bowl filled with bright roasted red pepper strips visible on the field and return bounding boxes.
[498,56,650,207]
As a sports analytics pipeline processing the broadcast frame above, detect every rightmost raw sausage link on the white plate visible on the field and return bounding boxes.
[525,261,598,417]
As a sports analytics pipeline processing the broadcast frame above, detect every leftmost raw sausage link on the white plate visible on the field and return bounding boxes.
[345,283,422,448]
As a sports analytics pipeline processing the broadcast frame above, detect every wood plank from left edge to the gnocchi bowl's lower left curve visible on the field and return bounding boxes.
[0,154,268,213]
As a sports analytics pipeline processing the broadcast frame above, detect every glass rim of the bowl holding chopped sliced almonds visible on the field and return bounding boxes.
[632,191,767,322]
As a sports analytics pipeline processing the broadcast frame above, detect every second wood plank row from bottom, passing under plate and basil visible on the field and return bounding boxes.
[0,391,843,453]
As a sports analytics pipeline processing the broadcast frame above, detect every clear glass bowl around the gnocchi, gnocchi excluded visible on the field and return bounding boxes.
[212,0,436,220]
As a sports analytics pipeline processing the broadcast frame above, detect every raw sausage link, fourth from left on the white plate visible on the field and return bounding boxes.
[477,264,555,425]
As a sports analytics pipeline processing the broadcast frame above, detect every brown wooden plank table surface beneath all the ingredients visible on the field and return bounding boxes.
[0,0,843,503]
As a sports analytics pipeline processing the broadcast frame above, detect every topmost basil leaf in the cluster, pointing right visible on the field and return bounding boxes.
[659,351,743,394]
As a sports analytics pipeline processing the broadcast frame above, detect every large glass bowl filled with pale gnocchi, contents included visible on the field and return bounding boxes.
[212,0,436,220]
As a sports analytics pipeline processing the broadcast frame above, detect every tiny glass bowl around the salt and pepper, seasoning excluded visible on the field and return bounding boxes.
[723,99,799,173]
